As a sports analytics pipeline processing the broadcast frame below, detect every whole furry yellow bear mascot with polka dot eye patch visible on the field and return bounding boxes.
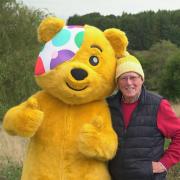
[3,17,128,180]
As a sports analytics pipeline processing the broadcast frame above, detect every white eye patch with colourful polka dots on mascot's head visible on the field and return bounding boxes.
[35,26,84,76]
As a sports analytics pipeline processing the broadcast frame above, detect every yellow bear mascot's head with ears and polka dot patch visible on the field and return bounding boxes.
[35,17,128,104]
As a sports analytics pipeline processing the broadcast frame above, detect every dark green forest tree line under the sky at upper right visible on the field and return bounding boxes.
[68,10,180,50]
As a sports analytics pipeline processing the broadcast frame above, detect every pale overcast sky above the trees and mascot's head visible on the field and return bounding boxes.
[18,0,180,20]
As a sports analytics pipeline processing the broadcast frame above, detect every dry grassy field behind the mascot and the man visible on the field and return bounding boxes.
[0,104,180,180]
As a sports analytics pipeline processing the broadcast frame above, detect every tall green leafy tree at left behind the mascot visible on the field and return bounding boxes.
[0,0,45,119]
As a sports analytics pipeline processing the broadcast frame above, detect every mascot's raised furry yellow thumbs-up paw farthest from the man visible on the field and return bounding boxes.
[3,96,44,137]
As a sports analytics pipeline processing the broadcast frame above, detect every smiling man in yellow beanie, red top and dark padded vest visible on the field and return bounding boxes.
[107,55,180,180]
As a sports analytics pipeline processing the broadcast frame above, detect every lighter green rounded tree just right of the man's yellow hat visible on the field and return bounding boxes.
[135,40,179,91]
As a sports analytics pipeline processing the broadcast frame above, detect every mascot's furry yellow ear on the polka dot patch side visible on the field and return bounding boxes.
[37,17,64,43]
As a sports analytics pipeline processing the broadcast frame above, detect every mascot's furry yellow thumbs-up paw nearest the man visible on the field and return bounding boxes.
[79,112,118,161]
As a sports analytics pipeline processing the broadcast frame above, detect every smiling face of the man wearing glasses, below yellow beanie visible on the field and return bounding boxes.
[118,72,144,100]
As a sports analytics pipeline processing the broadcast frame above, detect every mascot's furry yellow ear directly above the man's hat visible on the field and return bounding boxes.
[104,28,128,58]
